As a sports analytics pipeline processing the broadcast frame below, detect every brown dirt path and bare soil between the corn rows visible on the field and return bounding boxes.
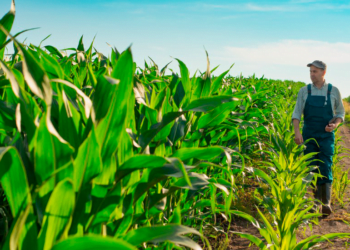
[228,125,350,250]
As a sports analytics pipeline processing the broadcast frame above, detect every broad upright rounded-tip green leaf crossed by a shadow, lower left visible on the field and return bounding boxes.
[38,179,75,250]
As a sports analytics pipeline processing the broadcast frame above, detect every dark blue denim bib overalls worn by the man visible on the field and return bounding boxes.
[303,84,335,185]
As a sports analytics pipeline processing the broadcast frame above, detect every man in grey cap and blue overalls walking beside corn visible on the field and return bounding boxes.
[292,60,345,215]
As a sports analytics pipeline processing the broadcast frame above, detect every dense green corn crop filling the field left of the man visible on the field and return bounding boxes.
[0,2,349,250]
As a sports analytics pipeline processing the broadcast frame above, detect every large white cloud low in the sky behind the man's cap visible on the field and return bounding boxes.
[225,40,350,66]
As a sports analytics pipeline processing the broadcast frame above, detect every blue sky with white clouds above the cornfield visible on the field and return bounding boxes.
[0,0,350,97]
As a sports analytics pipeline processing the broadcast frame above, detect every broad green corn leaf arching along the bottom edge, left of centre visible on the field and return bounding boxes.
[52,235,137,250]
